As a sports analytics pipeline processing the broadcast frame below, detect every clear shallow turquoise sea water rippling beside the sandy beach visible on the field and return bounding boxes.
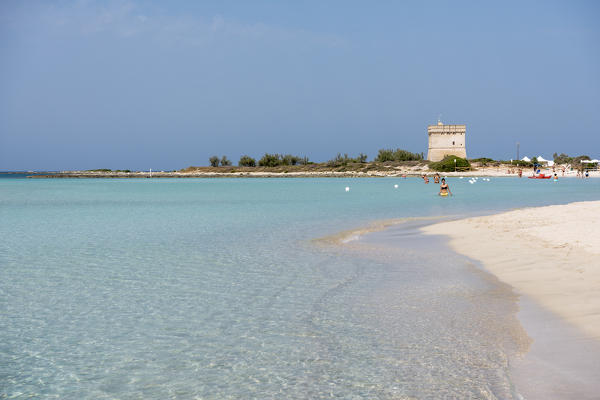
[0,178,600,399]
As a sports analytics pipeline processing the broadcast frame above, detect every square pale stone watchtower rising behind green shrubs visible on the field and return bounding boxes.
[427,121,467,161]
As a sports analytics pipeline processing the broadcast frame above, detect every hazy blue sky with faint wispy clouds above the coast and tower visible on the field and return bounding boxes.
[0,0,600,170]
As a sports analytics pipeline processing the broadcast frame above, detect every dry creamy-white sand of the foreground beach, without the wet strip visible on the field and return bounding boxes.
[423,201,600,339]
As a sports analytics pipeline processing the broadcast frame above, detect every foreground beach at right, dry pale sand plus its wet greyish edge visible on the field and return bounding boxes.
[421,201,600,399]
